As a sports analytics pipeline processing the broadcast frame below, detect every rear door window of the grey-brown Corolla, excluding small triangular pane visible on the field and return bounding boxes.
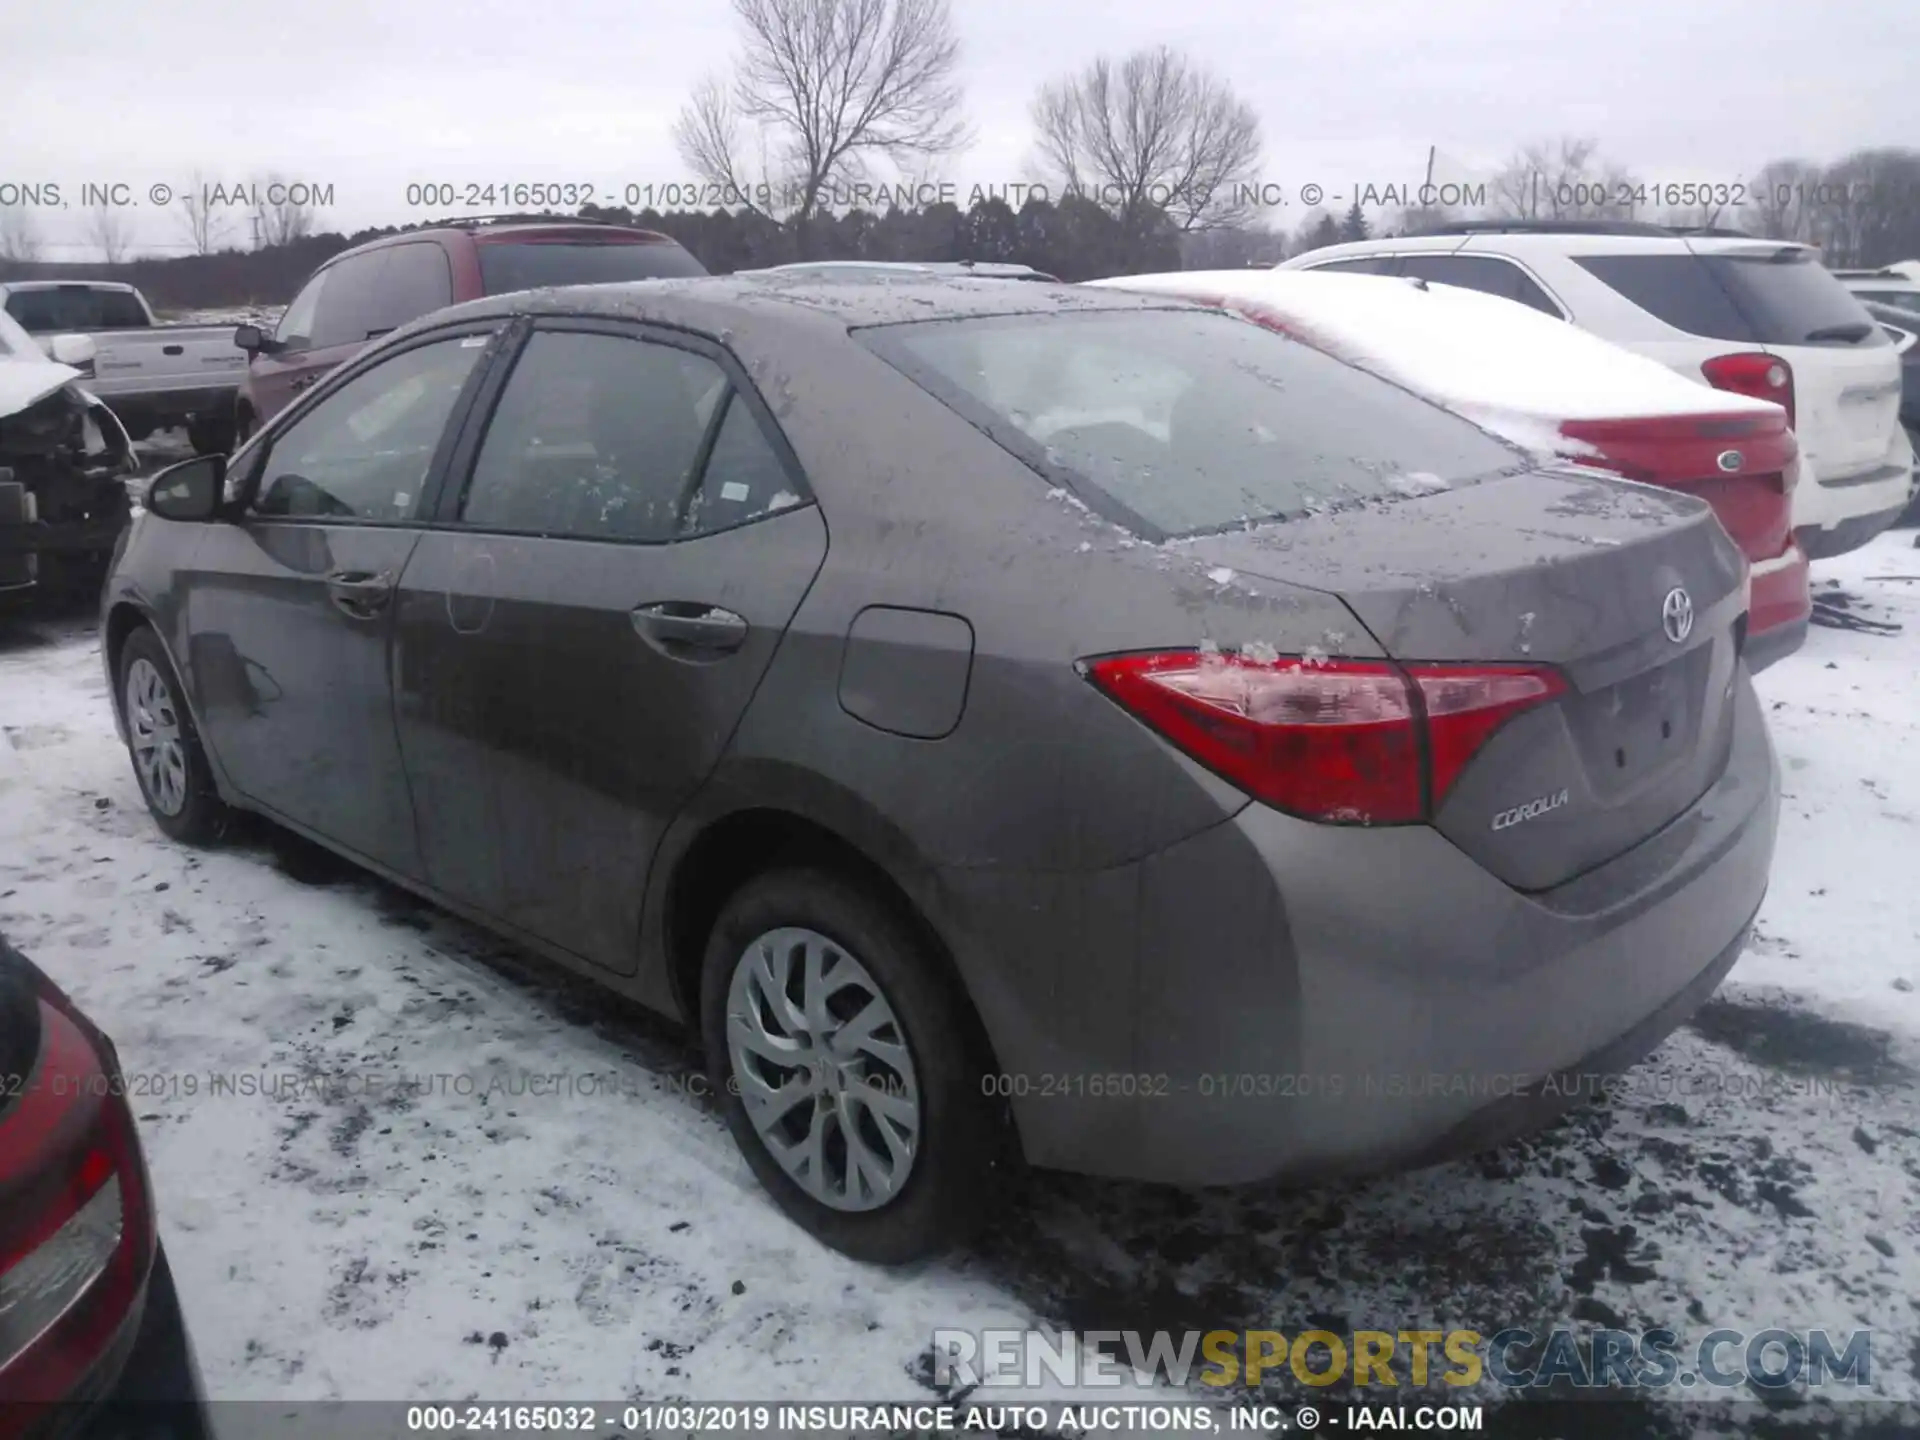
[461,330,726,540]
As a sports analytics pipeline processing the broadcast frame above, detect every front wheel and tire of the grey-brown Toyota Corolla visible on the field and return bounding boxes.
[117,626,232,845]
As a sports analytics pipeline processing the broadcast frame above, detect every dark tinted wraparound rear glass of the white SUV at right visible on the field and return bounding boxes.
[1576,250,1887,348]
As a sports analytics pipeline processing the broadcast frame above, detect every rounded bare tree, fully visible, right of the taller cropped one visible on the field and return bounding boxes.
[1033,46,1260,232]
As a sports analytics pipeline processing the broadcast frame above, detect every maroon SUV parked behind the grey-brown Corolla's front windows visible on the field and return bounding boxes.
[234,219,707,444]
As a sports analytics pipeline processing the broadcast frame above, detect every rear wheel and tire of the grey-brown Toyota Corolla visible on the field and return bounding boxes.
[701,870,1008,1265]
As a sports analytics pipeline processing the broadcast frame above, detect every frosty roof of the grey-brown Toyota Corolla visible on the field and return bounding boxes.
[396,271,1190,334]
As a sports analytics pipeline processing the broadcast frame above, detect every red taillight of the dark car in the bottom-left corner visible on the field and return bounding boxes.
[0,993,154,1413]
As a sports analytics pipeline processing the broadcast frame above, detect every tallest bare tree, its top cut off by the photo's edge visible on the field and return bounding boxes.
[674,0,972,221]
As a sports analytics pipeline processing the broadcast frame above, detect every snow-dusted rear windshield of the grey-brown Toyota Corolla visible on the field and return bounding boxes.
[858,309,1526,540]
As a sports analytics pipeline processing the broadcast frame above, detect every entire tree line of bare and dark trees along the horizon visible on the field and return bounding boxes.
[0,0,1920,307]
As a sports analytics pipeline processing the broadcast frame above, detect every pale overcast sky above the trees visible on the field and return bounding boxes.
[0,0,1920,259]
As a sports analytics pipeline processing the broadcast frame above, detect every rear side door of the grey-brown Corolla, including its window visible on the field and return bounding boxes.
[396,319,828,973]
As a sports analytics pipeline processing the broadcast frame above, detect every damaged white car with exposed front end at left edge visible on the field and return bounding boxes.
[0,315,138,603]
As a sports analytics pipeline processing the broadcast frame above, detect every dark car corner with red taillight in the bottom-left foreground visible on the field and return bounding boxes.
[0,939,207,1440]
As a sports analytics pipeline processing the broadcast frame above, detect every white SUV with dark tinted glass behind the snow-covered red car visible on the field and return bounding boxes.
[1277,221,1914,559]
